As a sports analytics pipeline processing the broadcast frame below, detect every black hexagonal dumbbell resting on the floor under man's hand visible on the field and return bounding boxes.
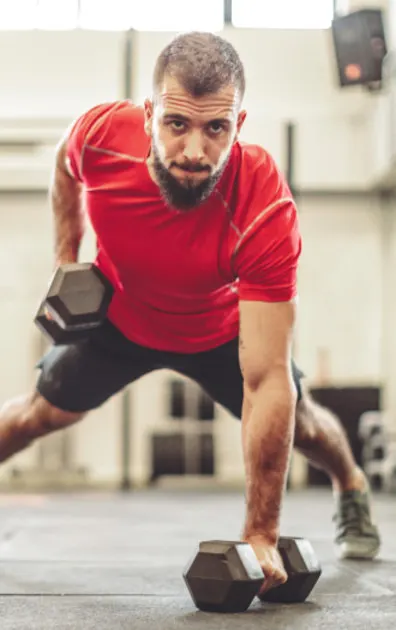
[183,537,322,613]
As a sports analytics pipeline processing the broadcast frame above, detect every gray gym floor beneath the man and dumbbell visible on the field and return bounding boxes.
[0,488,396,630]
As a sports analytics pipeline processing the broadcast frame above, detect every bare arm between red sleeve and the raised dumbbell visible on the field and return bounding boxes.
[50,143,84,266]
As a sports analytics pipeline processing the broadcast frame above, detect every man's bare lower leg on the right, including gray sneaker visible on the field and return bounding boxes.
[294,389,381,559]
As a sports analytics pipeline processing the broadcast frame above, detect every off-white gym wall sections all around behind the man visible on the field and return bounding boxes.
[0,24,396,482]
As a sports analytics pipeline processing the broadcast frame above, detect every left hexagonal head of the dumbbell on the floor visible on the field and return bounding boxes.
[183,540,264,613]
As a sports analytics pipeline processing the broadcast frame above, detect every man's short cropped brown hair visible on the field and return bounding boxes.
[153,31,245,100]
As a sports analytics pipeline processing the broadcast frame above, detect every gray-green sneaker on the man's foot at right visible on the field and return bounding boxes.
[333,490,381,560]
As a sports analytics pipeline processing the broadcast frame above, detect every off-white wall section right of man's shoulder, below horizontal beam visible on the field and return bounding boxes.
[296,197,383,384]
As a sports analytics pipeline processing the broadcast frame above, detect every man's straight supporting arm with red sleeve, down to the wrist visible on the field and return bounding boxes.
[234,163,301,546]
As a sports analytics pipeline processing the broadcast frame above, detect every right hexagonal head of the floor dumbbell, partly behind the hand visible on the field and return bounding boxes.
[259,537,322,604]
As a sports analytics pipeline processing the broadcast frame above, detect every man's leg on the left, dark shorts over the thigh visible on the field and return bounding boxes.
[0,322,155,462]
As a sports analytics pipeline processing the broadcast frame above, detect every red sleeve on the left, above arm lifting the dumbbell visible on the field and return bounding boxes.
[66,103,113,182]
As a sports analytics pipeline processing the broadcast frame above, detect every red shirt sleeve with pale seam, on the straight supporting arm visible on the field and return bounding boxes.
[234,156,301,302]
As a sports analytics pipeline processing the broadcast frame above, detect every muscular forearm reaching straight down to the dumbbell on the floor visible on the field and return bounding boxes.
[242,370,296,544]
